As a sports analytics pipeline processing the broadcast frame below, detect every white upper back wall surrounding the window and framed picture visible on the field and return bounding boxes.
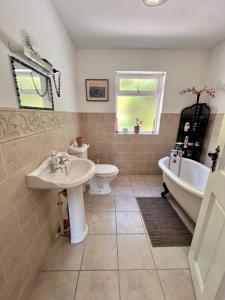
[76,49,209,113]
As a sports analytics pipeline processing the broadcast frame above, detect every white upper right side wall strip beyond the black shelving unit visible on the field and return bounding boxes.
[208,41,225,113]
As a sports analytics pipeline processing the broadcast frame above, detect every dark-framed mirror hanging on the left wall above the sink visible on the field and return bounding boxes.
[10,56,54,110]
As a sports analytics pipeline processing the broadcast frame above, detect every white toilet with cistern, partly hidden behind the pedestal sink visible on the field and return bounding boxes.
[69,144,119,195]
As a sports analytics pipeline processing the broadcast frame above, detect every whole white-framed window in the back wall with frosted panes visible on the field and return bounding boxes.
[116,72,166,133]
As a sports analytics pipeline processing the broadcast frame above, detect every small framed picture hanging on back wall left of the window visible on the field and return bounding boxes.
[85,79,109,101]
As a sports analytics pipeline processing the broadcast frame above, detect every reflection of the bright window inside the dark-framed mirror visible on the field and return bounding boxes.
[17,75,44,107]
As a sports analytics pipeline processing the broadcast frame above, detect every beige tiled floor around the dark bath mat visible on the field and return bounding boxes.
[30,175,195,300]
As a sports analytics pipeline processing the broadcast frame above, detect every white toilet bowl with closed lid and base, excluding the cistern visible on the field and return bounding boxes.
[88,164,119,195]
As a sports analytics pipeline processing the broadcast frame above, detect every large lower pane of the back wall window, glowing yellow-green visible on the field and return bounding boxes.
[117,96,157,132]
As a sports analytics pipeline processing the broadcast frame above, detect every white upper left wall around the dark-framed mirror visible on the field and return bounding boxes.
[0,0,78,111]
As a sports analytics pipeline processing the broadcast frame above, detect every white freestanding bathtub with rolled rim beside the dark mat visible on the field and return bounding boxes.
[159,157,210,223]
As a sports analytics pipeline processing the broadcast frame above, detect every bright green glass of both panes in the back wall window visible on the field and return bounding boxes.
[117,78,158,132]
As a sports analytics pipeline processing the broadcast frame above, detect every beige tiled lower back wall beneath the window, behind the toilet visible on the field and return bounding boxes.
[80,113,180,174]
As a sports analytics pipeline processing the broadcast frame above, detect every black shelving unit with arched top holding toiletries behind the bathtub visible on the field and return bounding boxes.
[177,103,211,161]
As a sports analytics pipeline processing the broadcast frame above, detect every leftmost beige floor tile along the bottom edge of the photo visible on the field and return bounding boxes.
[29,271,78,300]
